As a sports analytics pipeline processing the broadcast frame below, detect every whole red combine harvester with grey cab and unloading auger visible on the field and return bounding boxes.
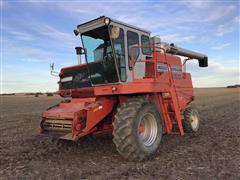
[40,16,208,161]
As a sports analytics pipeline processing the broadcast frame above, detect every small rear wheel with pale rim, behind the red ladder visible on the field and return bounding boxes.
[183,107,200,133]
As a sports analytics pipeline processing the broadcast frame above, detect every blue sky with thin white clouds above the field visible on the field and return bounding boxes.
[0,0,240,93]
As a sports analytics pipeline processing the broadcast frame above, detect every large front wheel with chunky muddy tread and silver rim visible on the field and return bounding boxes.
[113,97,163,161]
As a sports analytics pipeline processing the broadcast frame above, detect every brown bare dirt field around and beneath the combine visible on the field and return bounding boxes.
[0,88,240,179]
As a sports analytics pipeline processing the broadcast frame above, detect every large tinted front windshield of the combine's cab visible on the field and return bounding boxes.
[82,26,119,84]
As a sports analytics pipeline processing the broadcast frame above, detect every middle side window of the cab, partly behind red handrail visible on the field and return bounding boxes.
[127,31,139,68]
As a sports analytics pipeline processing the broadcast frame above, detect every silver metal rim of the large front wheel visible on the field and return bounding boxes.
[138,113,157,146]
